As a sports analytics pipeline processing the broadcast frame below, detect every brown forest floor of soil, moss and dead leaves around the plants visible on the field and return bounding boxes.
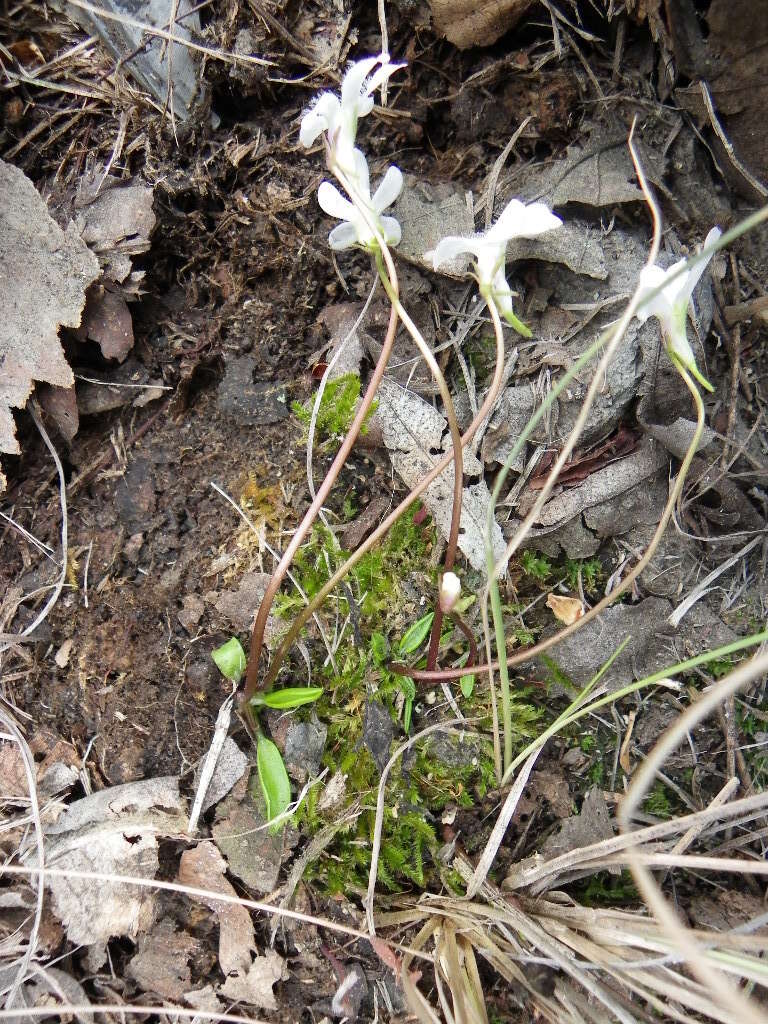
[0,0,768,1024]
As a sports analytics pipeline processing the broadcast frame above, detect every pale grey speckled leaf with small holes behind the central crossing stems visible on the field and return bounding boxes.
[376,379,504,571]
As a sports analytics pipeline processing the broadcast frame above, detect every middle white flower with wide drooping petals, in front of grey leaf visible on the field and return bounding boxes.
[432,199,562,338]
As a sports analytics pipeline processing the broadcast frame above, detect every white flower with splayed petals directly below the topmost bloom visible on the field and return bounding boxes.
[317,150,402,250]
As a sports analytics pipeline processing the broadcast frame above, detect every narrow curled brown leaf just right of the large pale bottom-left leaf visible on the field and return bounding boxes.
[178,843,256,980]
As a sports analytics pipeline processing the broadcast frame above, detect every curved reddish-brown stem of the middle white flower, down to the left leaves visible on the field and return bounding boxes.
[265,299,512,686]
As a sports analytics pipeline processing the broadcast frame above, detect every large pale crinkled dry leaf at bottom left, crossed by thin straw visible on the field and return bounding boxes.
[24,776,186,945]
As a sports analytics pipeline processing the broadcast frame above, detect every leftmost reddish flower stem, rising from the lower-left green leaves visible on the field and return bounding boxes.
[243,306,397,708]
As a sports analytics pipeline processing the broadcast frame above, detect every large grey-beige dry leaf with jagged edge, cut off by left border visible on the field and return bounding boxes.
[0,155,99,464]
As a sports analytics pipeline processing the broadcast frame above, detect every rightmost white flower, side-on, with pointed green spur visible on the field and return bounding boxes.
[635,227,722,391]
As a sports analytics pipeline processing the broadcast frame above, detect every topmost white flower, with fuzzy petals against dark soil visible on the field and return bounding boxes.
[299,53,406,175]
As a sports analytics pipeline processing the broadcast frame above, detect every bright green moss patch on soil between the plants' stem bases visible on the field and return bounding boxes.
[275,508,543,894]
